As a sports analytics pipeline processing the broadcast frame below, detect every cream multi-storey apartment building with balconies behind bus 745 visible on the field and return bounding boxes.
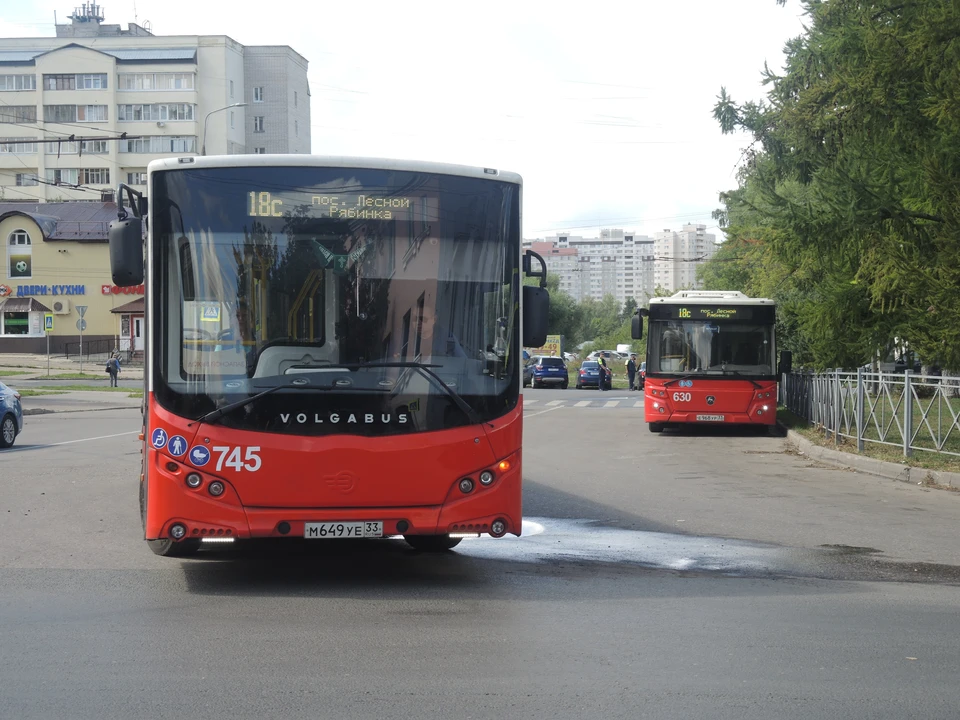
[0,3,311,202]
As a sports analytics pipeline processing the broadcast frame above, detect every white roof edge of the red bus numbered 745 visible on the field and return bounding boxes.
[147,154,523,185]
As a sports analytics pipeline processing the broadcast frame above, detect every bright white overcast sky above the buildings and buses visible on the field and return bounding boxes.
[0,0,805,240]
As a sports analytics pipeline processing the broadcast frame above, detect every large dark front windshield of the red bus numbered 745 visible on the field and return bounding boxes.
[150,167,520,434]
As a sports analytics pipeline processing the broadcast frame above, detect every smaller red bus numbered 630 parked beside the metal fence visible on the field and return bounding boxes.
[633,290,791,433]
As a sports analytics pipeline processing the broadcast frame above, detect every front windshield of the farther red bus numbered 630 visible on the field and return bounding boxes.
[647,320,774,378]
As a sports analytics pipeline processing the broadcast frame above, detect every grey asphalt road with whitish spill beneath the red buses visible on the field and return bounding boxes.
[0,408,960,720]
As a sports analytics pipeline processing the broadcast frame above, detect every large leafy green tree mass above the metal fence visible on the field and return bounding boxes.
[701,0,960,367]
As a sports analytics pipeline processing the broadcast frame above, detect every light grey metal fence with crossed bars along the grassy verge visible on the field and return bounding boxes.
[780,370,960,456]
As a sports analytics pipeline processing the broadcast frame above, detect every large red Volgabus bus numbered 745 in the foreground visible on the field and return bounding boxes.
[110,155,549,556]
